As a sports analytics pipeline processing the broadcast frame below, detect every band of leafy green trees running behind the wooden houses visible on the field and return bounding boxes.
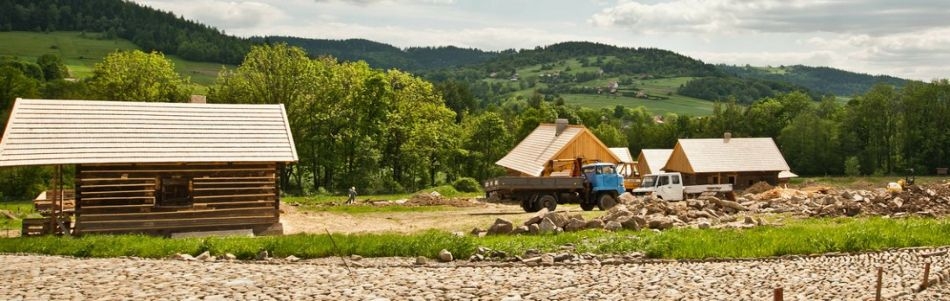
[0,44,950,197]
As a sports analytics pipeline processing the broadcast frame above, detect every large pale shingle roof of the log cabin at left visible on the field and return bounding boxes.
[0,99,297,166]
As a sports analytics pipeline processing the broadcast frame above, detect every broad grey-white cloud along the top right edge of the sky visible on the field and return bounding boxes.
[589,0,950,35]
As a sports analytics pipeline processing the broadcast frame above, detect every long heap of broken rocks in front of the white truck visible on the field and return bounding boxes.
[480,182,950,235]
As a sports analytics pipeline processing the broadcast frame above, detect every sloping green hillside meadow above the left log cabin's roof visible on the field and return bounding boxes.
[0,31,223,85]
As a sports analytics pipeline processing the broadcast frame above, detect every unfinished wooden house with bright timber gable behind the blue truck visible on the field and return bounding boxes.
[495,119,621,177]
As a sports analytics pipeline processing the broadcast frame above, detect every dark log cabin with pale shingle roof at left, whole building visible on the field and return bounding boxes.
[0,99,297,235]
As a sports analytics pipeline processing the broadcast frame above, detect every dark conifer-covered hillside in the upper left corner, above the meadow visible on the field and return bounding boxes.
[0,0,251,64]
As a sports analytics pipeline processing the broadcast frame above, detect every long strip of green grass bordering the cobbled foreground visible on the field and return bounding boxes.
[0,217,950,259]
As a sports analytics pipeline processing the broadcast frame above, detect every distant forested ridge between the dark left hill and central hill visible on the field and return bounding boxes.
[260,36,498,72]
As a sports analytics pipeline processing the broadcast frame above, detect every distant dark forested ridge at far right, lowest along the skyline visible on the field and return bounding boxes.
[716,65,908,96]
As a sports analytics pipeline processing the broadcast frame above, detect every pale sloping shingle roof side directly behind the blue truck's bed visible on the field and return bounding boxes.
[495,124,586,176]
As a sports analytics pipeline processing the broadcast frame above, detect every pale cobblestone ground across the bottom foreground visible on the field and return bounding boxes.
[0,247,950,300]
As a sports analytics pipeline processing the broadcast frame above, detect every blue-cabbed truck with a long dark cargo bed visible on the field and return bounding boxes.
[484,162,624,212]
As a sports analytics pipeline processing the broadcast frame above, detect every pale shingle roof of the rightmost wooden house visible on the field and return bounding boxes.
[677,138,789,173]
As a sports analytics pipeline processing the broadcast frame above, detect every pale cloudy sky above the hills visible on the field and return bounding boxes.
[133,0,950,81]
